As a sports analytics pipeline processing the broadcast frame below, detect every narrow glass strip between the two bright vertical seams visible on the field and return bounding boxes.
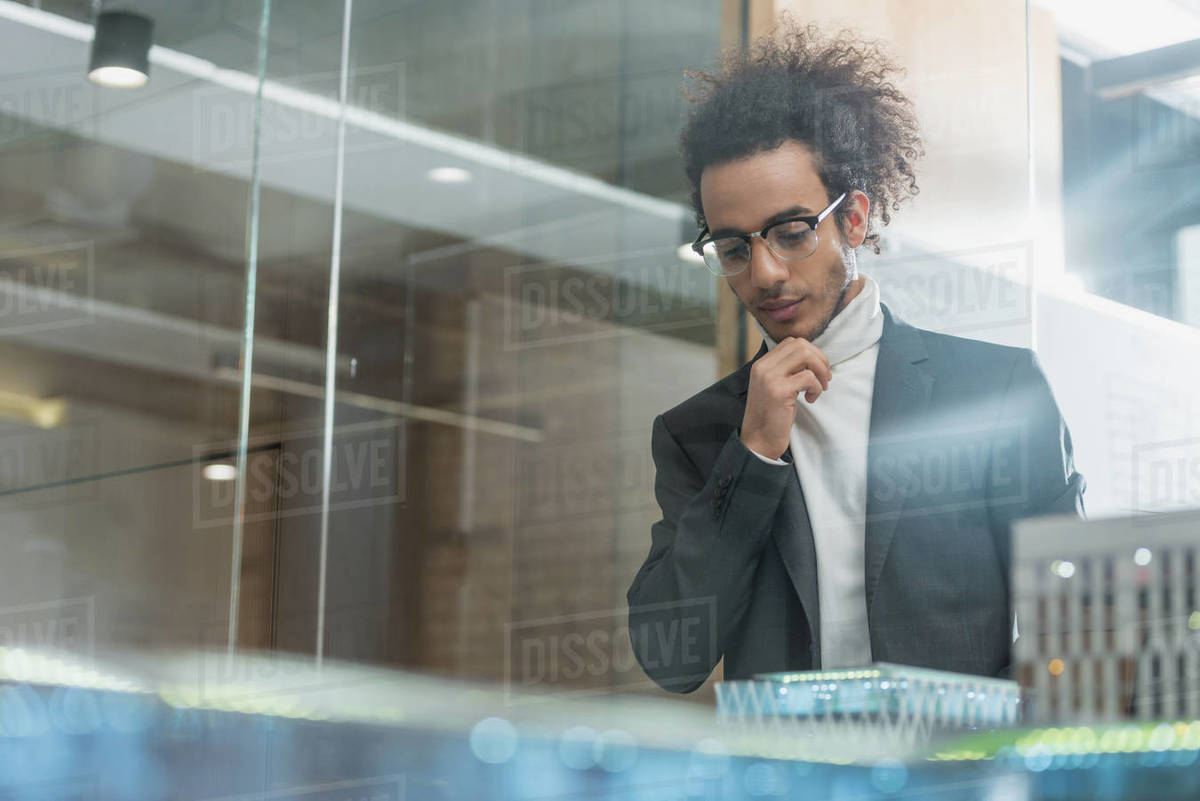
[219,2,348,661]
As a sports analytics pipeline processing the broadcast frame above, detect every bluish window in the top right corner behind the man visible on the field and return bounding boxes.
[1046,0,1200,325]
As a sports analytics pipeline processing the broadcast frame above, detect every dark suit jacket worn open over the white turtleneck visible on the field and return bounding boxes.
[628,306,1085,692]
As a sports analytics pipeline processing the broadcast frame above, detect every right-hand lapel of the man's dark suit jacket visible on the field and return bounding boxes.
[865,306,934,613]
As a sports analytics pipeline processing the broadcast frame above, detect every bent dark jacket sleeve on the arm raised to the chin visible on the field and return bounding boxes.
[626,415,793,692]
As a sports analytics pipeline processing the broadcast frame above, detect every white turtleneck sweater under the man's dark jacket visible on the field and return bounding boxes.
[751,276,883,669]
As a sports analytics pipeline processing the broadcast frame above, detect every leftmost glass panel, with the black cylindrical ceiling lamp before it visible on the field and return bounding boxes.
[0,2,269,660]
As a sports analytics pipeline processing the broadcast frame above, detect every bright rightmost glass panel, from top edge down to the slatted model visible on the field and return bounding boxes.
[1036,0,1200,514]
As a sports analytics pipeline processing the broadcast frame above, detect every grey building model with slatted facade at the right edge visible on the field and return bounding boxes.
[1013,511,1200,723]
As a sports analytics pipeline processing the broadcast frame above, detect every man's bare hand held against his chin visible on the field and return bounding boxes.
[742,337,833,459]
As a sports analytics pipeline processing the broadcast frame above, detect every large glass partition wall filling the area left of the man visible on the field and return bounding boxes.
[0,0,737,692]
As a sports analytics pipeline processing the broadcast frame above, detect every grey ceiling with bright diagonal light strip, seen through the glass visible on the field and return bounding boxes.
[0,0,719,434]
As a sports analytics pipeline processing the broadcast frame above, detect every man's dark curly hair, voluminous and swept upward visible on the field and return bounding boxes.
[679,16,924,253]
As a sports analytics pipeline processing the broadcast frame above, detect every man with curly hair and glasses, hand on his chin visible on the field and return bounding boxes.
[628,21,1085,692]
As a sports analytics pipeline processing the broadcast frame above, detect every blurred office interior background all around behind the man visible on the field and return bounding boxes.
[0,0,1200,797]
